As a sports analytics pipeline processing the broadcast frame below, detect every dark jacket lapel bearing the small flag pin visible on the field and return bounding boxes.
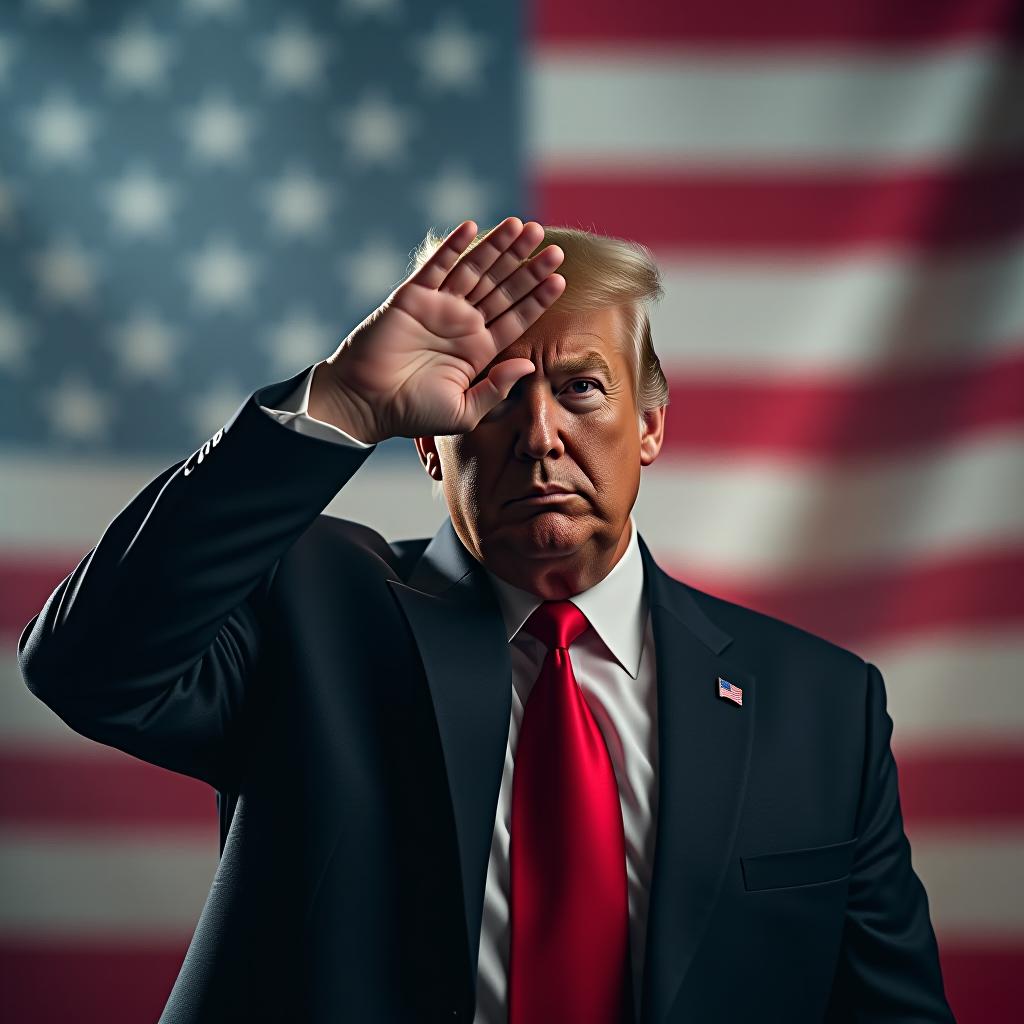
[639,537,757,1024]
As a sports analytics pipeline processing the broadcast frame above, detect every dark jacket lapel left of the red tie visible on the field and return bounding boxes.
[388,518,512,993]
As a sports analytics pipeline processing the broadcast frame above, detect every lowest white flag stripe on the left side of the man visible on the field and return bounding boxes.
[0,828,218,938]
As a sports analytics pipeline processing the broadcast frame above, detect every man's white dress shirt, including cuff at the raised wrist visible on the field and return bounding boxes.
[254,371,657,1024]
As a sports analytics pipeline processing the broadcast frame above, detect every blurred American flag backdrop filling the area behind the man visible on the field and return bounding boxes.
[0,0,1024,1024]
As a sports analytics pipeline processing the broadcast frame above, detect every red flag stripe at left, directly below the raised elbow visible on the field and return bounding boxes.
[0,744,218,835]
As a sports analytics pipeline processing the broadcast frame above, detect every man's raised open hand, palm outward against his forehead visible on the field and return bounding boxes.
[309,217,565,443]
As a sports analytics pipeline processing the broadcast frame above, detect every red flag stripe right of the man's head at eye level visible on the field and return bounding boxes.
[663,348,1024,462]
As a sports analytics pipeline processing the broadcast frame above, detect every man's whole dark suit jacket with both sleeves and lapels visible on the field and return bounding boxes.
[18,367,952,1024]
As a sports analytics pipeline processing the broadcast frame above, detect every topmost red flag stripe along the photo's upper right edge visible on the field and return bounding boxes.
[528,0,1024,49]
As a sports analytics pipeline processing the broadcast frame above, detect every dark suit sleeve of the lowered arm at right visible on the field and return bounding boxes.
[825,663,955,1024]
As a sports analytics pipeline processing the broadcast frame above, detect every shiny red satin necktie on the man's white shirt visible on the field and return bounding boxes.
[509,601,633,1024]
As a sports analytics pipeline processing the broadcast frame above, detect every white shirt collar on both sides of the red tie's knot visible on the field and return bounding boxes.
[481,512,647,679]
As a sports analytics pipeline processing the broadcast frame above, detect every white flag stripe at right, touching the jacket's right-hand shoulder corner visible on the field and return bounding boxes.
[858,627,1024,756]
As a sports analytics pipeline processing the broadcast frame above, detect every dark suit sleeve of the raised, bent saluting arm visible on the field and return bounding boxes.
[17,368,375,790]
